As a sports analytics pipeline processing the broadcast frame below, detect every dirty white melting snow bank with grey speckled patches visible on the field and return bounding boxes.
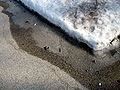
[18,0,120,51]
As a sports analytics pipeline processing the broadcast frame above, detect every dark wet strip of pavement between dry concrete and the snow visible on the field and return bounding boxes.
[0,0,120,90]
